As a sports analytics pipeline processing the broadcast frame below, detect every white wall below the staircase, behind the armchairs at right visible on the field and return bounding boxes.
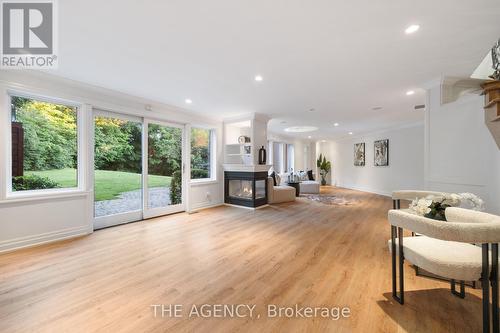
[425,85,500,214]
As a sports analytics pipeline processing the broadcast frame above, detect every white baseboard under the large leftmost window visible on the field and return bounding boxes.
[0,226,93,253]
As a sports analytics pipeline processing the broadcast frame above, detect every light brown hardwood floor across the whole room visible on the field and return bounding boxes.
[0,188,481,332]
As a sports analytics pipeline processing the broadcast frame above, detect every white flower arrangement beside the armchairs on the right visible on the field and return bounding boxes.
[409,193,484,221]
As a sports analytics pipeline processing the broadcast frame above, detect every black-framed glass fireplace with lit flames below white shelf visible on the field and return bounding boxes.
[224,171,267,208]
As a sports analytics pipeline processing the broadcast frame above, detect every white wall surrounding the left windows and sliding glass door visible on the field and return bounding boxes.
[0,71,223,251]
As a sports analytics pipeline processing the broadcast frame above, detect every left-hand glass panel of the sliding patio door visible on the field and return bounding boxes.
[94,112,143,229]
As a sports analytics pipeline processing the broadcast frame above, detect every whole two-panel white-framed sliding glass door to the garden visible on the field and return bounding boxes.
[94,111,185,229]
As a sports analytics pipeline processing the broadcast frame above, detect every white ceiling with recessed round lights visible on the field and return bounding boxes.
[55,0,500,139]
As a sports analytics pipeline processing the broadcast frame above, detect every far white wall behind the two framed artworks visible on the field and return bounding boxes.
[330,124,424,195]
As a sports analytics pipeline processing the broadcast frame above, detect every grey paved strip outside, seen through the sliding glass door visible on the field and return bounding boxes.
[94,187,170,217]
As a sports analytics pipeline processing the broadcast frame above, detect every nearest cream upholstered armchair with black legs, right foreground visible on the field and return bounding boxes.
[389,204,500,333]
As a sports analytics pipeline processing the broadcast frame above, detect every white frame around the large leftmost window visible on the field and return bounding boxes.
[5,89,85,200]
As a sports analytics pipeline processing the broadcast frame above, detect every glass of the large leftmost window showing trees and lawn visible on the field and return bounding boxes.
[10,96,78,192]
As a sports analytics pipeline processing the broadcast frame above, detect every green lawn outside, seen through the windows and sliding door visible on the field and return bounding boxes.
[26,169,172,201]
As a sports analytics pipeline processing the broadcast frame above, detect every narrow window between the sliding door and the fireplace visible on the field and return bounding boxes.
[191,127,214,179]
